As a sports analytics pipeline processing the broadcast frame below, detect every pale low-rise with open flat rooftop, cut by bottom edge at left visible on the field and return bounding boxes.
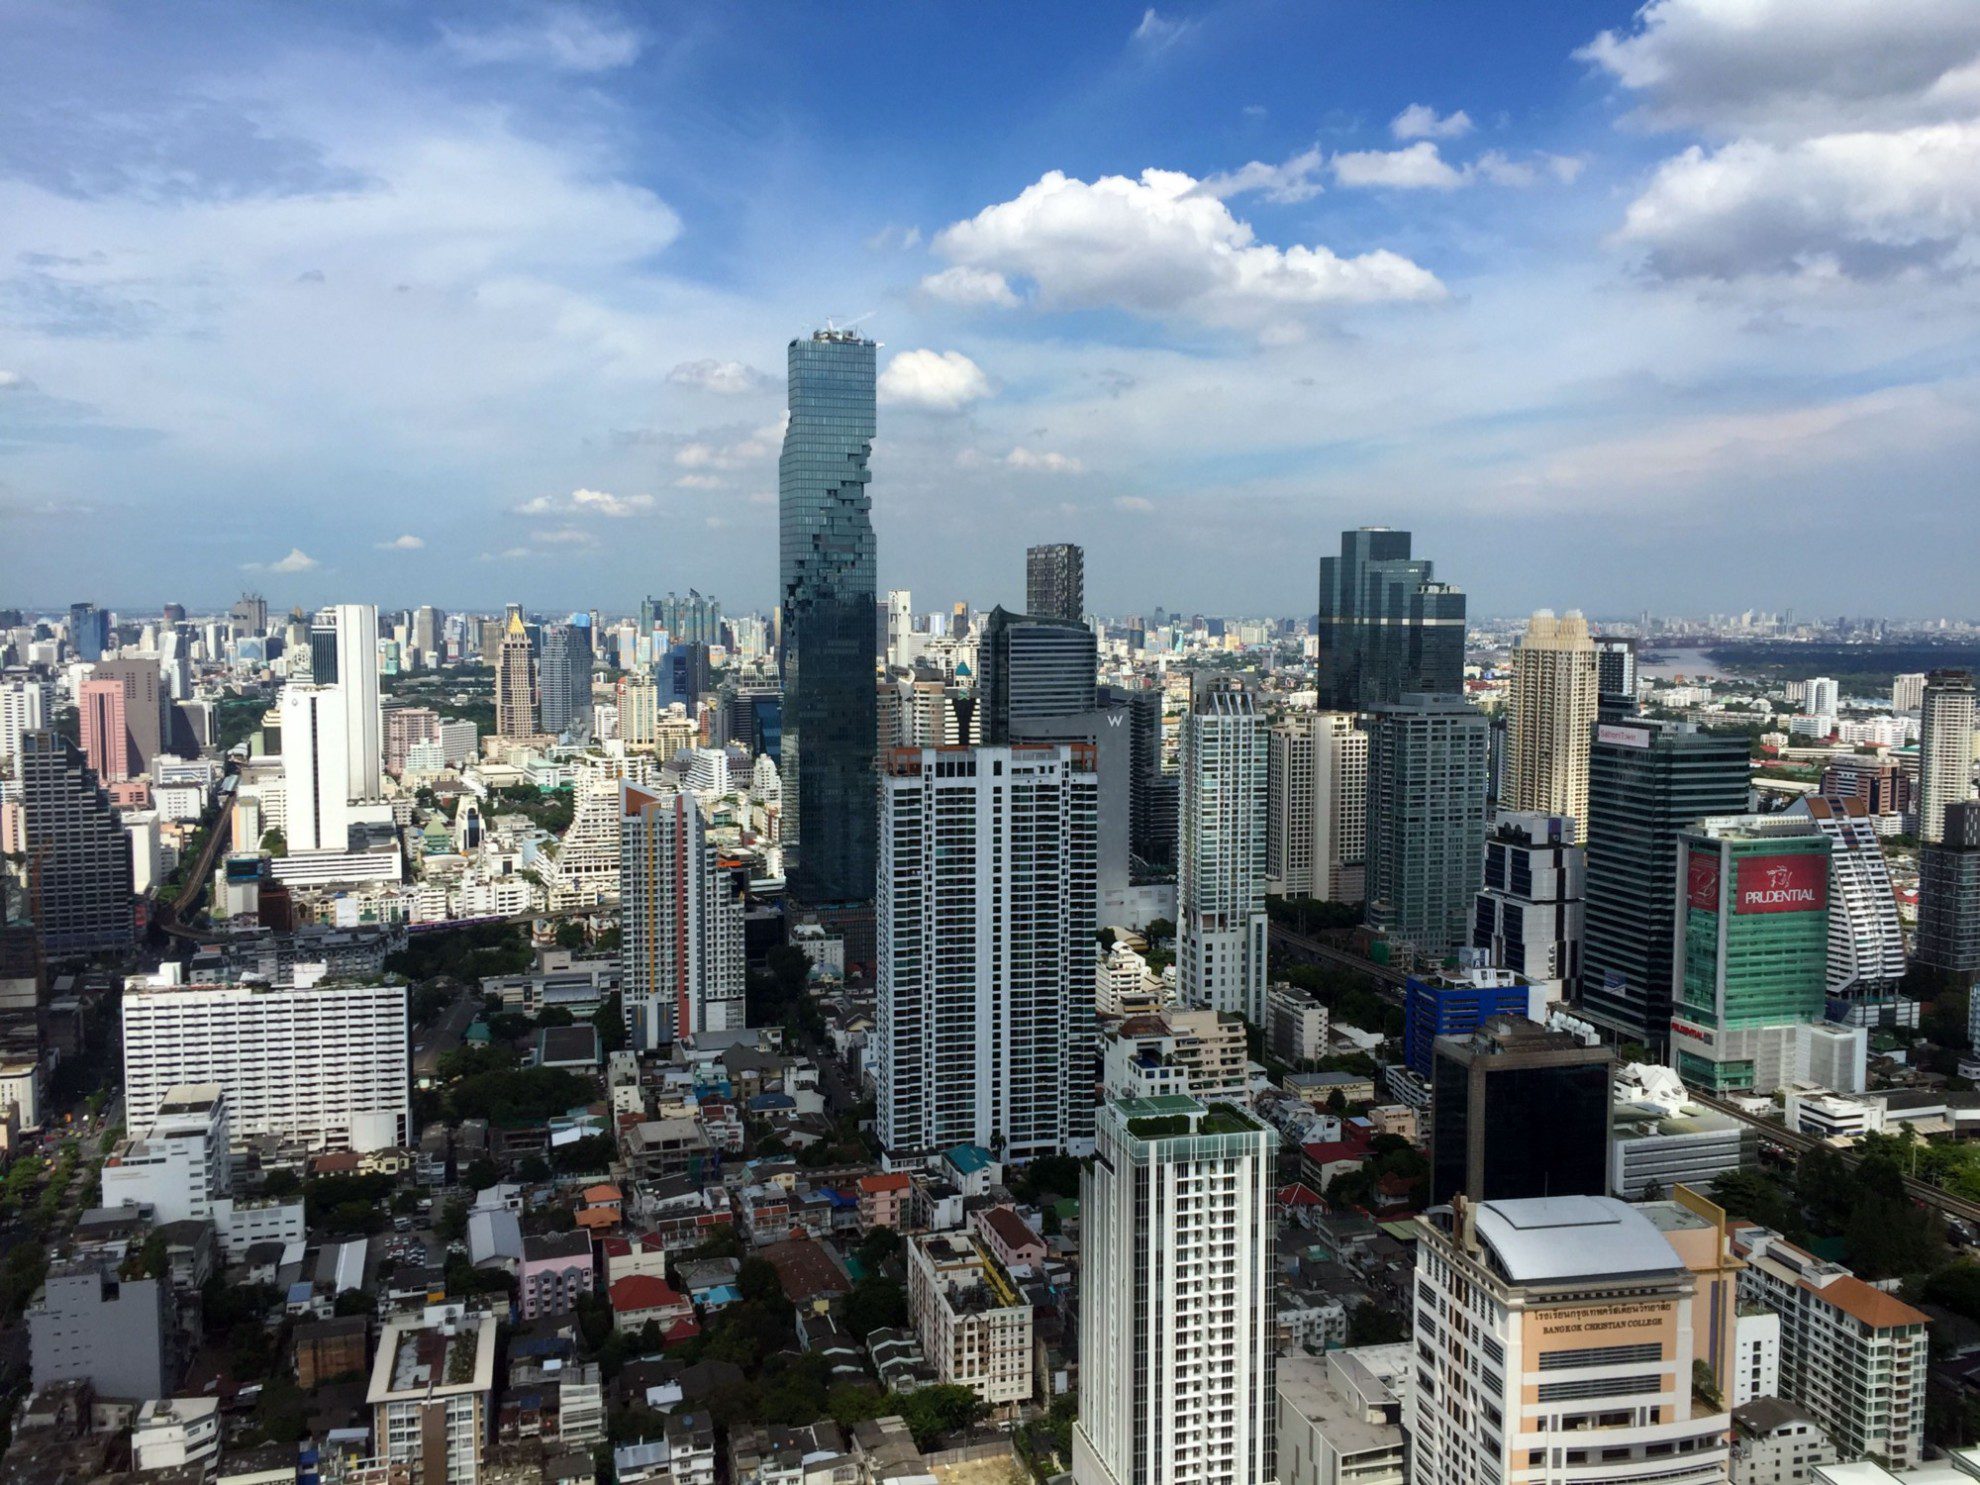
[364,1311,497,1485]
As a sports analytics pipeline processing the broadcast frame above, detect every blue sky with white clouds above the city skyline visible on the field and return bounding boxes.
[0,0,1980,616]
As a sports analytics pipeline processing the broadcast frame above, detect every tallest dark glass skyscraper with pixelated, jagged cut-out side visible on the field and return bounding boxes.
[778,329,879,907]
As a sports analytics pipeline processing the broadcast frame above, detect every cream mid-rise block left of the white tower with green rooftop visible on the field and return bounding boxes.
[907,1232,1032,1408]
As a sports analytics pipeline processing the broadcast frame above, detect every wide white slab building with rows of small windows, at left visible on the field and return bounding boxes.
[123,984,412,1150]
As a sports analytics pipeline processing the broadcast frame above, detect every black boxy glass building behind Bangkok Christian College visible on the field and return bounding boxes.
[1430,1016,1616,1202]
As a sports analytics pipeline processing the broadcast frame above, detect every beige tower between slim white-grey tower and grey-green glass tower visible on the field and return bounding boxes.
[1265,711,1368,903]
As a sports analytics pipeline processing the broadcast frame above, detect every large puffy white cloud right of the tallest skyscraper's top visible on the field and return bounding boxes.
[918,170,1443,329]
